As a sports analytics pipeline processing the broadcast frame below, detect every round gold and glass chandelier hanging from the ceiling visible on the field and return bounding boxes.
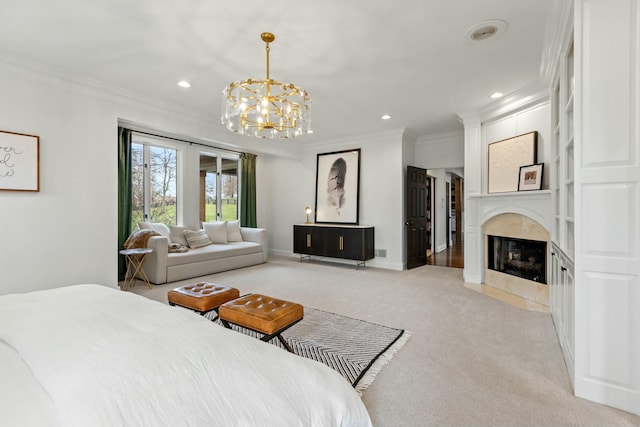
[221,33,312,139]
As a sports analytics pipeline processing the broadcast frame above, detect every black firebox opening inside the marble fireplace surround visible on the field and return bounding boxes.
[487,235,547,284]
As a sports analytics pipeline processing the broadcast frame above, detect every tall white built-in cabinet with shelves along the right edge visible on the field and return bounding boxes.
[549,0,640,414]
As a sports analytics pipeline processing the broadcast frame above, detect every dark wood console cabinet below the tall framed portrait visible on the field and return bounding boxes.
[293,224,375,268]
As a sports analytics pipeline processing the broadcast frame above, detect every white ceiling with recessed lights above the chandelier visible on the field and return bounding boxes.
[0,0,553,142]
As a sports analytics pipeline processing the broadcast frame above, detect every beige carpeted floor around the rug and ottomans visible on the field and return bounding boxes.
[134,257,640,427]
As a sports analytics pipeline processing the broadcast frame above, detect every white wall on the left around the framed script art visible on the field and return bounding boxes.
[0,63,276,294]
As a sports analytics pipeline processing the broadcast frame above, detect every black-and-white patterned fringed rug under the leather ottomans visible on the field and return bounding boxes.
[210,307,411,392]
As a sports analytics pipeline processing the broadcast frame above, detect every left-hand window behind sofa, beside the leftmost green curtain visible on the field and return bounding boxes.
[131,133,178,230]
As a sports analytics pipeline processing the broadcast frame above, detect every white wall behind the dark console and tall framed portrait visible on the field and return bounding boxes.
[267,129,404,270]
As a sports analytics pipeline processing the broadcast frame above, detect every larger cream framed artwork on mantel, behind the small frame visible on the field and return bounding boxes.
[487,131,542,193]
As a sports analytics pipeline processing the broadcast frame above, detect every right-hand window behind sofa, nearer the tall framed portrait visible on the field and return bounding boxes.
[200,153,238,222]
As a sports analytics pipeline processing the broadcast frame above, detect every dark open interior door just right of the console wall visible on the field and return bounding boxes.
[405,166,430,268]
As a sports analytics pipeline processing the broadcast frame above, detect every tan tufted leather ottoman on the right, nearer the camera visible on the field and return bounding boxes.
[218,294,304,353]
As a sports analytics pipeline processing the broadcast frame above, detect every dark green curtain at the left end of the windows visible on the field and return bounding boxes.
[118,127,131,280]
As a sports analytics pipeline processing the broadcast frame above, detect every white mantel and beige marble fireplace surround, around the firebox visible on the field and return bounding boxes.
[465,190,551,311]
